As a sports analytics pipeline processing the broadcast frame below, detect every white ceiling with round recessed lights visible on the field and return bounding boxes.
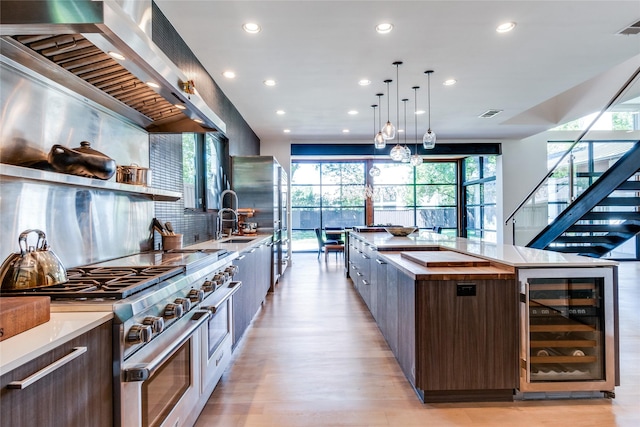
[155,0,640,143]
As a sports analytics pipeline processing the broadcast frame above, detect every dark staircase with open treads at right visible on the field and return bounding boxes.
[527,141,640,257]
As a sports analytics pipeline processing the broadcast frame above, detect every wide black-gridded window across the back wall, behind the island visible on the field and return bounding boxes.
[291,160,458,251]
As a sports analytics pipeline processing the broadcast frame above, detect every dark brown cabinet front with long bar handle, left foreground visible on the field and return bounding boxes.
[0,322,113,427]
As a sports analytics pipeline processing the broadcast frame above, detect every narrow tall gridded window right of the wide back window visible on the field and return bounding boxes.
[463,156,497,242]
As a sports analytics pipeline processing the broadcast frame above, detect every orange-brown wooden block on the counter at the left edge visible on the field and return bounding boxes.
[0,296,51,341]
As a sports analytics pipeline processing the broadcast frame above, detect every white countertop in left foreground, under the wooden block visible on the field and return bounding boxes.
[0,312,113,375]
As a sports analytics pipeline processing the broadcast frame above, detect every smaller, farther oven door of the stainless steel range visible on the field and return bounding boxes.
[202,282,242,400]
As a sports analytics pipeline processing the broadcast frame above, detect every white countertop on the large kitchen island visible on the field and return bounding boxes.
[352,231,618,268]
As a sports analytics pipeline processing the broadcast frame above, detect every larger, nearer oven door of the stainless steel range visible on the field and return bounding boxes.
[120,311,210,427]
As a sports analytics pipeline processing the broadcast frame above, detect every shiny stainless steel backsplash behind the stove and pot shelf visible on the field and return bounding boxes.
[0,56,154,268]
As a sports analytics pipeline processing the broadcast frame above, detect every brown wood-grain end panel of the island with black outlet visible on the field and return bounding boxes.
[416,280,518,390]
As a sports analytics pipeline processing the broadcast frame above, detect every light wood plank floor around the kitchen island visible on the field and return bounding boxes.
[196,253,640,427]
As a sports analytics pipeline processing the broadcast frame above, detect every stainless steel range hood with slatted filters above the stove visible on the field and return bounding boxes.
[0,0,226,133]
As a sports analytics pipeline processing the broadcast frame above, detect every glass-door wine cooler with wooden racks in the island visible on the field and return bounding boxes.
[518,268,616,397]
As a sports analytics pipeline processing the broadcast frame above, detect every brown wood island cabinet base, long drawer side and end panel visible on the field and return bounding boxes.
[348,238,519,402]
